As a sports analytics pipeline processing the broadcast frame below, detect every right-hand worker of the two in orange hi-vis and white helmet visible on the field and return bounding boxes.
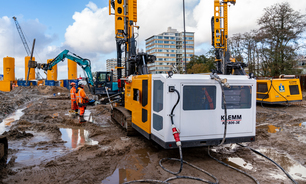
[77,81,88,123]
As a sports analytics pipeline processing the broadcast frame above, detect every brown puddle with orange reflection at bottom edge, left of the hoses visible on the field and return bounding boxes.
[102,149,151,184]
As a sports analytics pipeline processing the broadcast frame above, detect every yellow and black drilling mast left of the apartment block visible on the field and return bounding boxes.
[109,0,156,83]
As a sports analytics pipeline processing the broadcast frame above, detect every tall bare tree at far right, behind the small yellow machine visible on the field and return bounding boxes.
[258,2,306,76]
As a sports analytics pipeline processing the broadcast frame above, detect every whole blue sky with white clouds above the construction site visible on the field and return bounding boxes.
[0,0,306,79]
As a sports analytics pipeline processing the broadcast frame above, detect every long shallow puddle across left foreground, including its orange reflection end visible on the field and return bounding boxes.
[8,128,98,170]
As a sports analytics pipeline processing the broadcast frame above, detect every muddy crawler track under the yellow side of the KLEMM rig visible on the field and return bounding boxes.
[112,106,137,136]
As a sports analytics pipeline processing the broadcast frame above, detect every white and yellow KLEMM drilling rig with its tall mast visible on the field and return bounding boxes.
[109,0,256,149]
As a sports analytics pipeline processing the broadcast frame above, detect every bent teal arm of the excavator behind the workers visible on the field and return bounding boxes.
[37,50,94,86]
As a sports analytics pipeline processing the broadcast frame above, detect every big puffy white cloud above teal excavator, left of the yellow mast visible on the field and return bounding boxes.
[65,2,115,53]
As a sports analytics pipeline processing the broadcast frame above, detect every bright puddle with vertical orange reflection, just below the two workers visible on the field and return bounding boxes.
[60,128,98,148]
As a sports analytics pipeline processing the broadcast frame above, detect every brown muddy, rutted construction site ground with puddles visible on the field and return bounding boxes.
[0,86,306,184]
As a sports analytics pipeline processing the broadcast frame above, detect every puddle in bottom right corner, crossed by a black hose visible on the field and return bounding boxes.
[257,148,306,180]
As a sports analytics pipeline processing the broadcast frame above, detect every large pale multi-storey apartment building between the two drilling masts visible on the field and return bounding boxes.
[145,27,194,74]
